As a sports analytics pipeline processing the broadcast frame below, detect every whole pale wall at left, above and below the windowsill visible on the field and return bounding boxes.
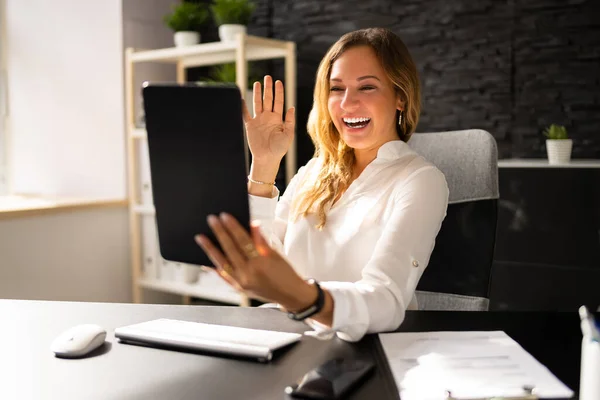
[0,0,181,303]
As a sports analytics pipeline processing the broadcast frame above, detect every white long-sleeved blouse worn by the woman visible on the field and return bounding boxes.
[249,140,448,341]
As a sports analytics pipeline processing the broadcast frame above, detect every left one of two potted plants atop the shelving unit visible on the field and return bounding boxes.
[164,2,209,47]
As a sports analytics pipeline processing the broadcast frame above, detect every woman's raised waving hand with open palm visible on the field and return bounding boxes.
[242,75,295,165]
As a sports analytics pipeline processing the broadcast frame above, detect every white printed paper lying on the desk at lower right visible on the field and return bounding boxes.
[379,331,573,400]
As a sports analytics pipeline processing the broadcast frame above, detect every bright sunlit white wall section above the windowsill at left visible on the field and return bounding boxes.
[5,0,126,199]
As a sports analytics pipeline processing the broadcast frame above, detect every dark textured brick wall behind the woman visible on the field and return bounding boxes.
[244,0,600,163]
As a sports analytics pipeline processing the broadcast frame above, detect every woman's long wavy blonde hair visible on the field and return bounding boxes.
[292,28,421,229]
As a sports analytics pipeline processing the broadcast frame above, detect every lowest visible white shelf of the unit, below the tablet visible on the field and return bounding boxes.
[138,273,242,305]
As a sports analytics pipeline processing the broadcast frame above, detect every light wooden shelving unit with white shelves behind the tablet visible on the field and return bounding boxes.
[125,34,296,306]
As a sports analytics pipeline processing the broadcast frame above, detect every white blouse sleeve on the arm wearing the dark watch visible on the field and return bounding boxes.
[307,167,448,341]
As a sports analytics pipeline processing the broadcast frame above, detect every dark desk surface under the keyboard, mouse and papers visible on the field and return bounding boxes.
[0,300,581,400]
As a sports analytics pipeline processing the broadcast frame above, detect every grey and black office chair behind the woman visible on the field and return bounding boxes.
[408,129,499,311]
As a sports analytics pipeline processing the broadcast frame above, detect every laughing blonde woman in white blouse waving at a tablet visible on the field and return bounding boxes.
[196,28,448,341]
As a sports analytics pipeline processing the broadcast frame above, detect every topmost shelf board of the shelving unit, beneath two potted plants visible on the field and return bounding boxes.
[130,35,288,68]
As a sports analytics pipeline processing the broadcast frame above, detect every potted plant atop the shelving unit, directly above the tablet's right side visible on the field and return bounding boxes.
[210,0,256,42]
